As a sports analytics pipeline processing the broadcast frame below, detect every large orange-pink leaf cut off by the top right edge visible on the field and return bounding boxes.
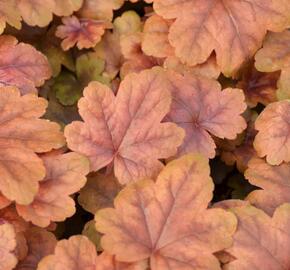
[154,0,290,77]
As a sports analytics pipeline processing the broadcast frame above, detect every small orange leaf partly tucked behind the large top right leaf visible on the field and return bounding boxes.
[142,15,174,58]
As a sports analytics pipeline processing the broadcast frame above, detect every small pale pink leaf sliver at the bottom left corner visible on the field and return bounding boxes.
[0,223,17,270]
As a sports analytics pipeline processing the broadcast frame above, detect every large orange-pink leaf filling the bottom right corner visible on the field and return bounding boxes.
[224,204,290,270]
